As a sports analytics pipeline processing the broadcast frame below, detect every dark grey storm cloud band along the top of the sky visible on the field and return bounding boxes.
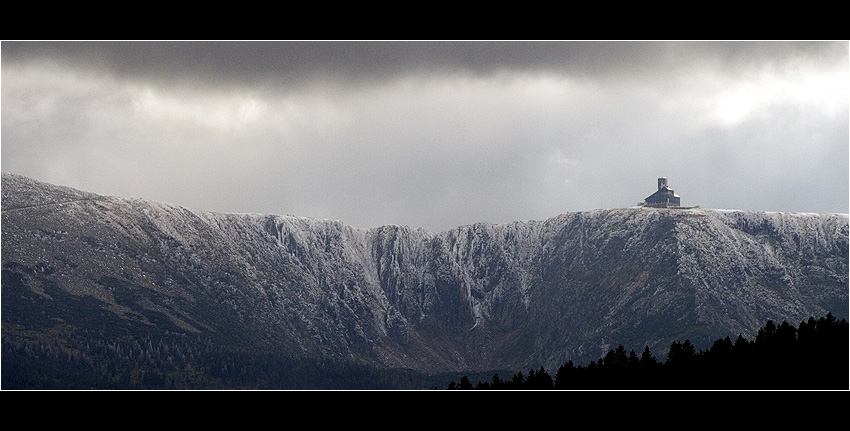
[3,41,835,90]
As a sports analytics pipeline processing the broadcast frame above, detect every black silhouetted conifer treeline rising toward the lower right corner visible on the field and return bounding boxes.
[447,313,850,390]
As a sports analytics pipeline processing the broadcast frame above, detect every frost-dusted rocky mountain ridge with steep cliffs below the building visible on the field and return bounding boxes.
[2,173,848,390]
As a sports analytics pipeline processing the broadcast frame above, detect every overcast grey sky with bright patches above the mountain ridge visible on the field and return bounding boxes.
[0,41,850,232]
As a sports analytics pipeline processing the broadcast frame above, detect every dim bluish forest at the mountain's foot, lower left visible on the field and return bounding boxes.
[2,334,434,390]
